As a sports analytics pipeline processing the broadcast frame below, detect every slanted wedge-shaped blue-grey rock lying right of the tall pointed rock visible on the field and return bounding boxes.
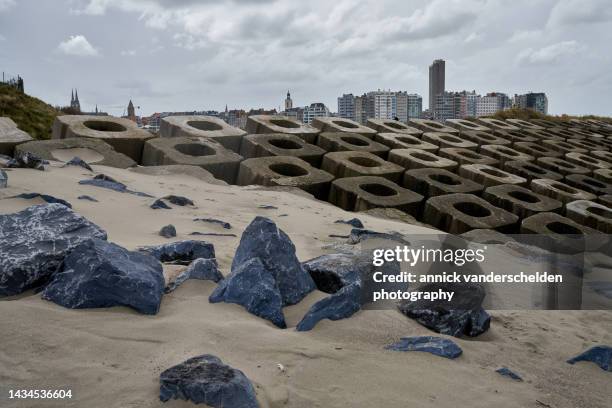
[297,283,361,331]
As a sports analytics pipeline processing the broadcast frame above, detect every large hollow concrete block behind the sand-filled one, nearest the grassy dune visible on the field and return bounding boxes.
[52,115,154,163]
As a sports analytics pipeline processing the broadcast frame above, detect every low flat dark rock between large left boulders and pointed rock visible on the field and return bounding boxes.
[138,240,215,265]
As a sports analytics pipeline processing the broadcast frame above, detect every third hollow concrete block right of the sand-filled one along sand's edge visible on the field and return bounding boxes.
[329,176,423,216]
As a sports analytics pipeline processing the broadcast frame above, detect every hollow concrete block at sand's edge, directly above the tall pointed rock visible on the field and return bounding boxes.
[236,156,334,199]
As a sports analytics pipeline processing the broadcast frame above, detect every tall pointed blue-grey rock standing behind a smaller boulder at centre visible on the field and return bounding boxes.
[232,217,315,306]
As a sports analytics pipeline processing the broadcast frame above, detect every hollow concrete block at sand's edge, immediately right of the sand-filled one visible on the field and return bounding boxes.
[142,137,242,184]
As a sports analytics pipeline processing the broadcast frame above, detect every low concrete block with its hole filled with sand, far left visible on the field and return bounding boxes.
[15,138,137,169]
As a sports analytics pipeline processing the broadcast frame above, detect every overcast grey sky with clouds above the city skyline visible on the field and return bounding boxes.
[0,0,612,116]
